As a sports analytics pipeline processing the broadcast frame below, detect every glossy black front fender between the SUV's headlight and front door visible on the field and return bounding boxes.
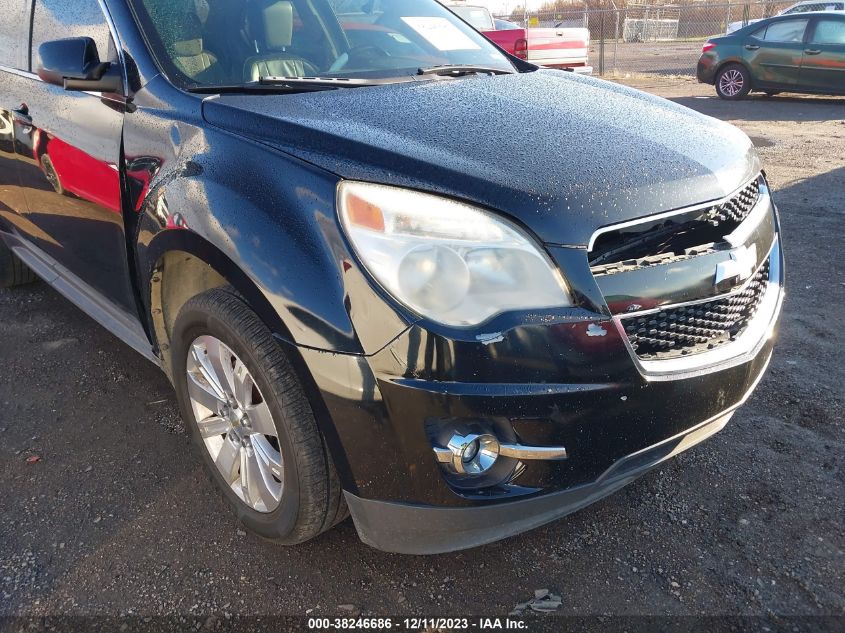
[124,78,409,355]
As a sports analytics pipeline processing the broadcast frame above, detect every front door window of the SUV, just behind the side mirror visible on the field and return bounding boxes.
[32,0,117,71]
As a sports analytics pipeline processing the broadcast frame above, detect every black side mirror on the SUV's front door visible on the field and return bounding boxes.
[38,37,123,93]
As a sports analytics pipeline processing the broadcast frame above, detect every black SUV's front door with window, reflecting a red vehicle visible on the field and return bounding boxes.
[13,0,138,320]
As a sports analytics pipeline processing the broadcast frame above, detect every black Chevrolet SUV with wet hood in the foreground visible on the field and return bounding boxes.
[0,0,783,553]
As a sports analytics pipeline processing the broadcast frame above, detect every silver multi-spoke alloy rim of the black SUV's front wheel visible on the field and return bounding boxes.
[187,336,284,512]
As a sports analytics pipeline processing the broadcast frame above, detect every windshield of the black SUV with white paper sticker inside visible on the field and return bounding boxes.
[130,0,514,88]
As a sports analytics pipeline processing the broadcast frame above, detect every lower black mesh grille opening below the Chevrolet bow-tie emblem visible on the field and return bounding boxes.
[622,261,769,360]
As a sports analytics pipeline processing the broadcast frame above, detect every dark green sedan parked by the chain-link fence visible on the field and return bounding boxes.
[697,12,845,99]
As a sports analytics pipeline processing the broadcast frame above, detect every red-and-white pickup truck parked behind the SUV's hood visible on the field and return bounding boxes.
[444,2,593,73]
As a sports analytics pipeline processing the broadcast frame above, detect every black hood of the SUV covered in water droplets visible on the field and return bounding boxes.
[203,70,760,245]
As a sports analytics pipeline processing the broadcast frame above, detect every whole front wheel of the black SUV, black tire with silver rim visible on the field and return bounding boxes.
[171,288,348,545]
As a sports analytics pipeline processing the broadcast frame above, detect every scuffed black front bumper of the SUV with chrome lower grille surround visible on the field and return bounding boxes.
[288,200,783,554]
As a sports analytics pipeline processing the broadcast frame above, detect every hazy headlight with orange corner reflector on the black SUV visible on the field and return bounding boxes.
[338,182,572,327]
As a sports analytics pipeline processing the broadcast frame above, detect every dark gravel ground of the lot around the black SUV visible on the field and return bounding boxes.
[0,82,845,630]
